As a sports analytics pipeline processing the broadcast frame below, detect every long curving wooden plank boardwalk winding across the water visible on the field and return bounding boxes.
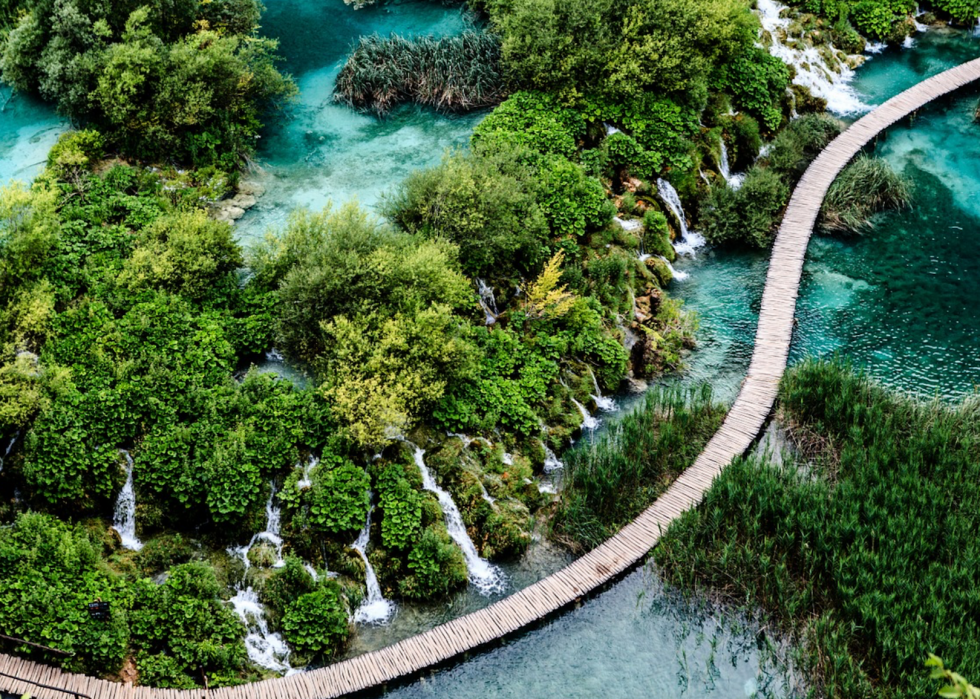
[0,59,980,699]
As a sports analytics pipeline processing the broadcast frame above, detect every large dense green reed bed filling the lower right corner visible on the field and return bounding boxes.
[654,361,980,697]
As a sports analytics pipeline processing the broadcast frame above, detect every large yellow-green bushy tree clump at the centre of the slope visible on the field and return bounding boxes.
[253,205,473,446]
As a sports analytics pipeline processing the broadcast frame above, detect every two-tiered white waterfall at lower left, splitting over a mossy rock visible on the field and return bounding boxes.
[228,487,293,673]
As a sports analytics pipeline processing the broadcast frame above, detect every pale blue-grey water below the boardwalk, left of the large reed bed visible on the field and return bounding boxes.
[364,570,791,699]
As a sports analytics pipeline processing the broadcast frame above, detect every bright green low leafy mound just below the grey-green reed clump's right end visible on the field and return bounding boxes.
[471,91,585,158]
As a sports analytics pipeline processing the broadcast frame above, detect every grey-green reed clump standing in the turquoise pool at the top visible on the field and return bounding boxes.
[335,32,506,115]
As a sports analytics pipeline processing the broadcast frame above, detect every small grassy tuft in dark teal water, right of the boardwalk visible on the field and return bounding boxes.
[820,155,912,233]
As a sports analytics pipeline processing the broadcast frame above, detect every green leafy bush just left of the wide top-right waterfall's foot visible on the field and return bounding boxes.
[717,46,789,131]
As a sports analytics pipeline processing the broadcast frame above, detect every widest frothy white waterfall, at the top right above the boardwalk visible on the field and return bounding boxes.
[756,0,870,114]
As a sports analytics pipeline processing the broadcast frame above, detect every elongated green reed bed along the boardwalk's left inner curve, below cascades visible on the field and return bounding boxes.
[552,385,726,550]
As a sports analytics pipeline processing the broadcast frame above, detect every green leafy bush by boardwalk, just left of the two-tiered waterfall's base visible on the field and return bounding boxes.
[129,563,246,687]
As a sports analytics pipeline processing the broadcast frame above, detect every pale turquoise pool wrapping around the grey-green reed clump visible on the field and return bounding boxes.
[236,0,483,242]
